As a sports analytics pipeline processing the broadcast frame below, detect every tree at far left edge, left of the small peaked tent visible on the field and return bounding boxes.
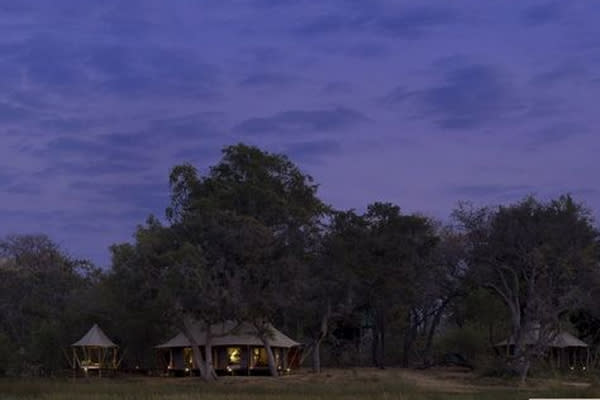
[0,235,96,374]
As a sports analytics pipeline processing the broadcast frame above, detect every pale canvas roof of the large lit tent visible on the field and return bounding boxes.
[156,321,300,349]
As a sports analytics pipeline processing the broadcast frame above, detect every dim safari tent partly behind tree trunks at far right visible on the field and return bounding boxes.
[495,329,590,371]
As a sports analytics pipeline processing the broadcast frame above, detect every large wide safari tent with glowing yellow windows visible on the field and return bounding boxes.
[156,321,300,375]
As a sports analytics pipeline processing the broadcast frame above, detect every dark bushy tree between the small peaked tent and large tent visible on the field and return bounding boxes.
[103,217,174,368]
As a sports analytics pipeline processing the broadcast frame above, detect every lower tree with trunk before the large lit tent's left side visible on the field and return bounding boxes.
[111,216,235,381]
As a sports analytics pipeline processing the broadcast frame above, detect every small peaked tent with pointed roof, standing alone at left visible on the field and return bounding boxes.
[71,324,119,376]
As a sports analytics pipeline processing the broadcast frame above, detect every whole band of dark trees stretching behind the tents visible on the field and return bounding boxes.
[0,144,600,380]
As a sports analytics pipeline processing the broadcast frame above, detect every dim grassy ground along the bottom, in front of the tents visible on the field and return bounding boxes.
[0,369,600,400]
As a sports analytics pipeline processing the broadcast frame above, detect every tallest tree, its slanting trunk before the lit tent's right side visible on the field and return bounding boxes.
[167,144,326,375]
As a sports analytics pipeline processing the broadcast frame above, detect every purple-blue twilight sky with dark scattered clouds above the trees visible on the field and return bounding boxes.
[0,0,600,266]
